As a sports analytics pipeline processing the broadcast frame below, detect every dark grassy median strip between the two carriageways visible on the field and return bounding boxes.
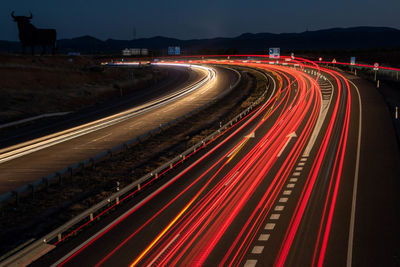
[0,65,266,253]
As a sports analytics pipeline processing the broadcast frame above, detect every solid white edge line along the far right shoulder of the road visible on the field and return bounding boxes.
[346,80,362,267]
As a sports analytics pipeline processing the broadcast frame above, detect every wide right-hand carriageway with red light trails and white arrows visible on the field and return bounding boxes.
[9,59,400,267]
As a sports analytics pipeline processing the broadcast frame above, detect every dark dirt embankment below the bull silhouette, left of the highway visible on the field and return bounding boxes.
[0,55,166,124]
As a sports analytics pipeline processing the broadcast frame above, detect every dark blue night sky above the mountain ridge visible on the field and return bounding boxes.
[0,0,400,41]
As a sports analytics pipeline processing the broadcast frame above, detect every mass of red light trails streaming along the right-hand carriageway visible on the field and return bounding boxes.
[39,55,360,266]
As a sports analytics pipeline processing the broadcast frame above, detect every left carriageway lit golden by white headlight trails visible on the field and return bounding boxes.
[0,64,238,193]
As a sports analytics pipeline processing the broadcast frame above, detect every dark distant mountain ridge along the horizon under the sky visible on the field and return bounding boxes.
[0,27,400,55]
